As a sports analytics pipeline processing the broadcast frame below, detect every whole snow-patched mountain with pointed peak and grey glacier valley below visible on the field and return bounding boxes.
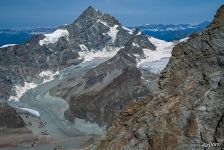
[0,7,170,149]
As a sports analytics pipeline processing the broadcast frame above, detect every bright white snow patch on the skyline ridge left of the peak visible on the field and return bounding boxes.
[39,29,69,46]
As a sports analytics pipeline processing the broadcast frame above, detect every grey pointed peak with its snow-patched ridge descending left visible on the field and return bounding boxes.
[0,6,145,100]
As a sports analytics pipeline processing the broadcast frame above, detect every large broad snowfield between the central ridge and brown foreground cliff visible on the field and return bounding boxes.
[137,37,175,73]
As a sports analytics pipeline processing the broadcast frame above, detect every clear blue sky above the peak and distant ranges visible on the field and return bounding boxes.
[0,0,224,28]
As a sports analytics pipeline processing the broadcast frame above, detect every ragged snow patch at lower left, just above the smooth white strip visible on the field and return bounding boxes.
[9,82,37,101]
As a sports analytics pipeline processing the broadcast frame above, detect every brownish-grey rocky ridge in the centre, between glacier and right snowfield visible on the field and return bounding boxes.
[51,31,152,127]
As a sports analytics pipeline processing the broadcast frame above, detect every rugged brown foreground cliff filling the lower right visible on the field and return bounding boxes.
[99,6,224,150]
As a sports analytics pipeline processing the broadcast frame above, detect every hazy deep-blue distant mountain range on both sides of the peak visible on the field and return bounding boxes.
[0,21,209,46]
